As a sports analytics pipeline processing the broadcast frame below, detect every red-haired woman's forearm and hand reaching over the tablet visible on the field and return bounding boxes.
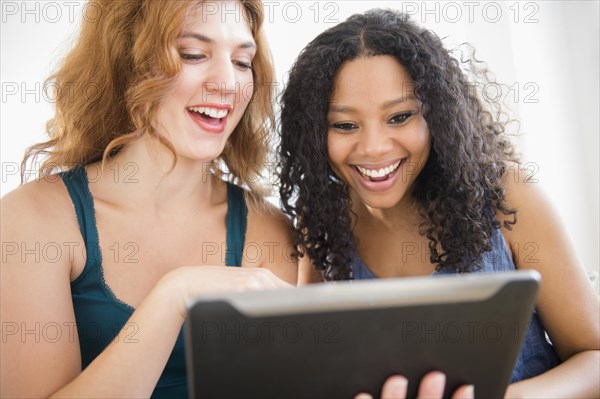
[53,266,289,398]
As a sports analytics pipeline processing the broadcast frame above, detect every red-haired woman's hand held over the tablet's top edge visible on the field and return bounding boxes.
[157,266,294,319]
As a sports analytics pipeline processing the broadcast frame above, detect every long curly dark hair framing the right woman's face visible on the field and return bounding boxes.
[279,9,517,280]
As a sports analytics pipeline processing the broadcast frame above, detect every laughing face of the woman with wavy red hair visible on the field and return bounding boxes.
[158,3,256,161]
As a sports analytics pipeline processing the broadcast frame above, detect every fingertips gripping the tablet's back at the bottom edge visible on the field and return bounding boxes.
[354,371,475,399]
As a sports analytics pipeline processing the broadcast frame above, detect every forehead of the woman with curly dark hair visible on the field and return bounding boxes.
[332,55,414,100]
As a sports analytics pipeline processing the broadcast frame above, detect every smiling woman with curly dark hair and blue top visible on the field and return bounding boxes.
[280,10,600,397]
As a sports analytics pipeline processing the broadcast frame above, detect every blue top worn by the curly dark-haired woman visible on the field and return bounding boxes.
[352,230,561,383]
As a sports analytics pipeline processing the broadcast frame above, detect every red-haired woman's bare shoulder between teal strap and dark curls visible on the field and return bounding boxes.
[242,195,298,284]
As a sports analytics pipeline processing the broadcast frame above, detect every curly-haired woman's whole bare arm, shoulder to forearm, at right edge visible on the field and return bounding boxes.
[504,167,600,398]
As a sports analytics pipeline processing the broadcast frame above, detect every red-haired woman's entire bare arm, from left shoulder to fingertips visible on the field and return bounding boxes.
[0,182,288,398]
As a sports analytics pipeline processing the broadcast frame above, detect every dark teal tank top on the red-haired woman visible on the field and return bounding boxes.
[60,168,247,398]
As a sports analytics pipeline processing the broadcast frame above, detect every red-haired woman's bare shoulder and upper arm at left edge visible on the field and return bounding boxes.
[0,182,83,397]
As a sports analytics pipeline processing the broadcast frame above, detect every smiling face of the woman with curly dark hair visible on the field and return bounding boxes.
[327,55,431,209]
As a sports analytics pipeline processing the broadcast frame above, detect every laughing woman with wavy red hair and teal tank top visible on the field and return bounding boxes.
[0,0,298,399]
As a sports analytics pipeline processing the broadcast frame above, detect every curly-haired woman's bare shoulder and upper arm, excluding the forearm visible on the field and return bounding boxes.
[504,167,600,360]
